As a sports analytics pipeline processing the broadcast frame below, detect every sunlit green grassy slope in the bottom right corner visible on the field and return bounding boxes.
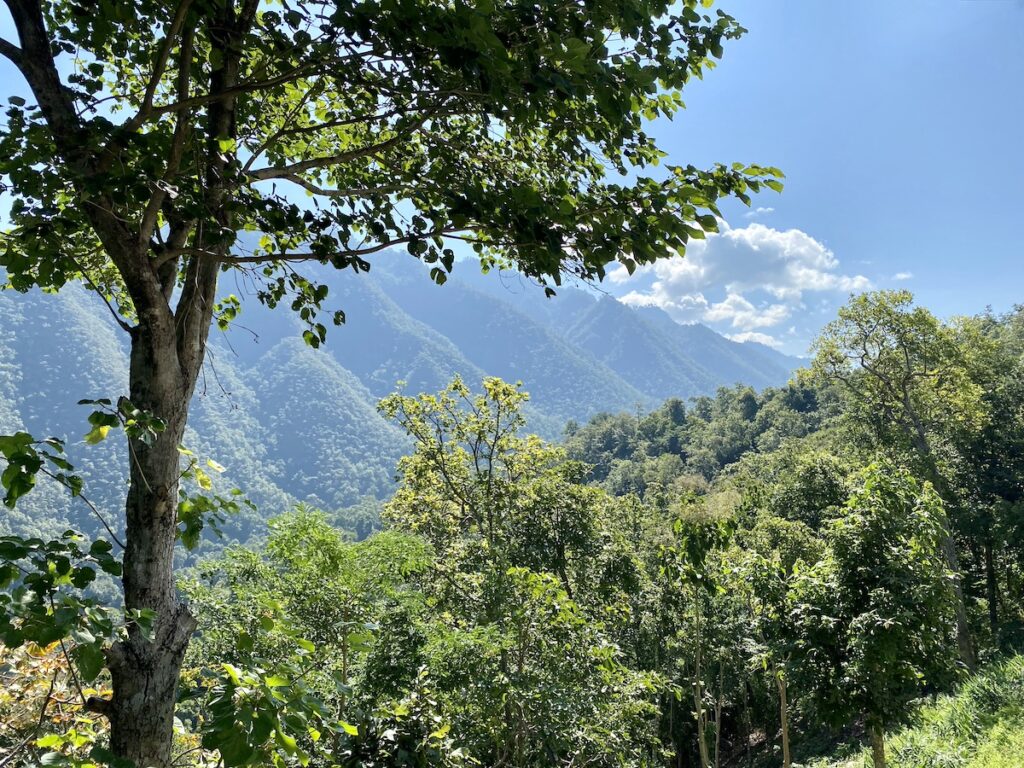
[807,656,1024,768]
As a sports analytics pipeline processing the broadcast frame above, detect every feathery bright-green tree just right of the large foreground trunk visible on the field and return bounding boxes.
[179,505,451,766]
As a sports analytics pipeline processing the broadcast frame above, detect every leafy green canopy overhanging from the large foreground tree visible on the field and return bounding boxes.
[0,0,780,339]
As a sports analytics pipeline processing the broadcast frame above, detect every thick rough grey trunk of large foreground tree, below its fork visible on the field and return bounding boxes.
[104,317,196,768]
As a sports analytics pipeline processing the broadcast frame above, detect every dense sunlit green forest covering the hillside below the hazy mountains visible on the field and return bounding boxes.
[0,292,1024,768]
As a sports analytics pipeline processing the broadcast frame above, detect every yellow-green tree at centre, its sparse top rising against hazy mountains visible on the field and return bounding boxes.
[380,378,654,766]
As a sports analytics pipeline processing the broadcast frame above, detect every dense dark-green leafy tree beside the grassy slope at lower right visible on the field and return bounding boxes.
[792,464,954,768]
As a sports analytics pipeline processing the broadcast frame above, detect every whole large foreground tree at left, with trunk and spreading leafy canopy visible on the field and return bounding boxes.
[0,0,778,766]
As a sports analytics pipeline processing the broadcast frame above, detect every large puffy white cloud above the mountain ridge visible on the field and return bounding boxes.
[609,223,871,333]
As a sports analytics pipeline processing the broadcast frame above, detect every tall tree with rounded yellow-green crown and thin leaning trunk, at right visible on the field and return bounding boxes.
[812,291,987,669]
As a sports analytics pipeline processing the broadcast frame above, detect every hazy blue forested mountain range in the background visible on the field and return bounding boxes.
[0,259,798,546]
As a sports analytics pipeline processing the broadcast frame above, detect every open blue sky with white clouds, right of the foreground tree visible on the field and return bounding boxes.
[609,0,1024,354]
